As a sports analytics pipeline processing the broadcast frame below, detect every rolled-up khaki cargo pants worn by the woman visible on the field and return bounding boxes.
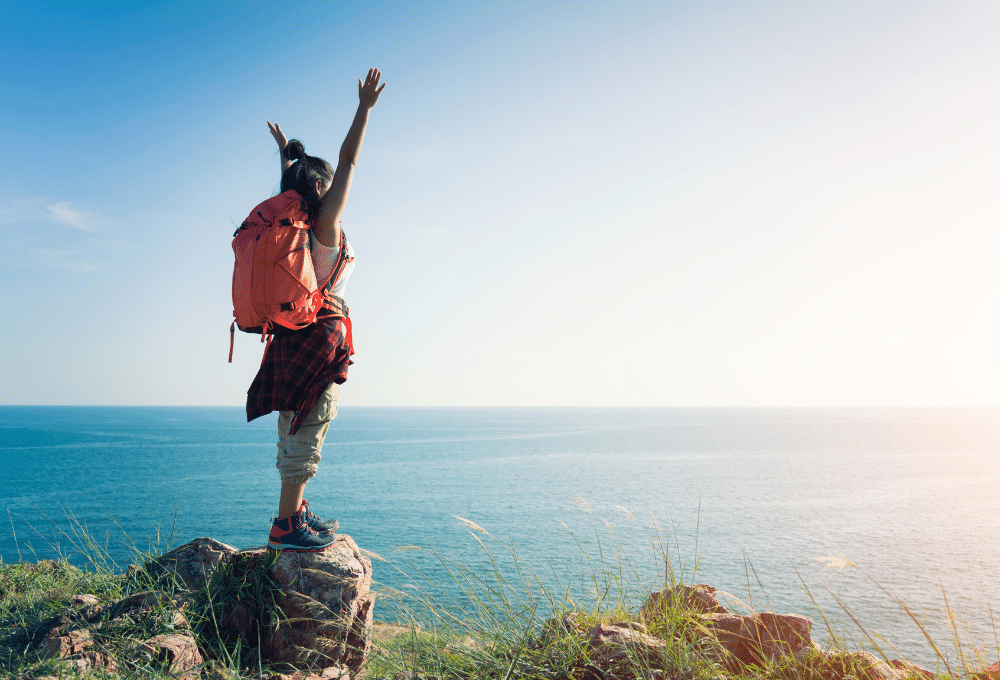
[276,383,340,484]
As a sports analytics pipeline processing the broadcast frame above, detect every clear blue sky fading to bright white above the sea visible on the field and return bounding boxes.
[0,0,1000,406]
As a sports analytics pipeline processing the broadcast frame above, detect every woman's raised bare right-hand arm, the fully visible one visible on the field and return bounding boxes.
[313,68,385,248]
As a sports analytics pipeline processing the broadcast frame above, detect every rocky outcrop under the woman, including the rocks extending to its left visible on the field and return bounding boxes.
[27,535,374,680]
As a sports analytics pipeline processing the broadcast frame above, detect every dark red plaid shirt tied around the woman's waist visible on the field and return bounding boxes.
[247,318,354,434]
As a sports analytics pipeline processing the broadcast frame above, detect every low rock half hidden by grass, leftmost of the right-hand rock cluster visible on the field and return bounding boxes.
[587,622,667,680]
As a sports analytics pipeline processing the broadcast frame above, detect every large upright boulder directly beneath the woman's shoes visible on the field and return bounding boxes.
[252,534,375,672]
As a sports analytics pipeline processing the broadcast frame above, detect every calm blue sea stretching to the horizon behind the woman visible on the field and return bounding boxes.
[0,407,1000,667]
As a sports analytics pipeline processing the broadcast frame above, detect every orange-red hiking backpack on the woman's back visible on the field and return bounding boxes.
[229,191,347,363]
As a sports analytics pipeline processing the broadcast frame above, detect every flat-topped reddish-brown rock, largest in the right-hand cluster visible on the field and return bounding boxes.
[704,612,815,670]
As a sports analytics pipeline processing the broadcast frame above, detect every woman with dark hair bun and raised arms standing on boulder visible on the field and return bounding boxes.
[247,69,385,552]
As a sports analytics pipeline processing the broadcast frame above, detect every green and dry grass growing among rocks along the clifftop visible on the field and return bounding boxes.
[0,504,1000,680]
